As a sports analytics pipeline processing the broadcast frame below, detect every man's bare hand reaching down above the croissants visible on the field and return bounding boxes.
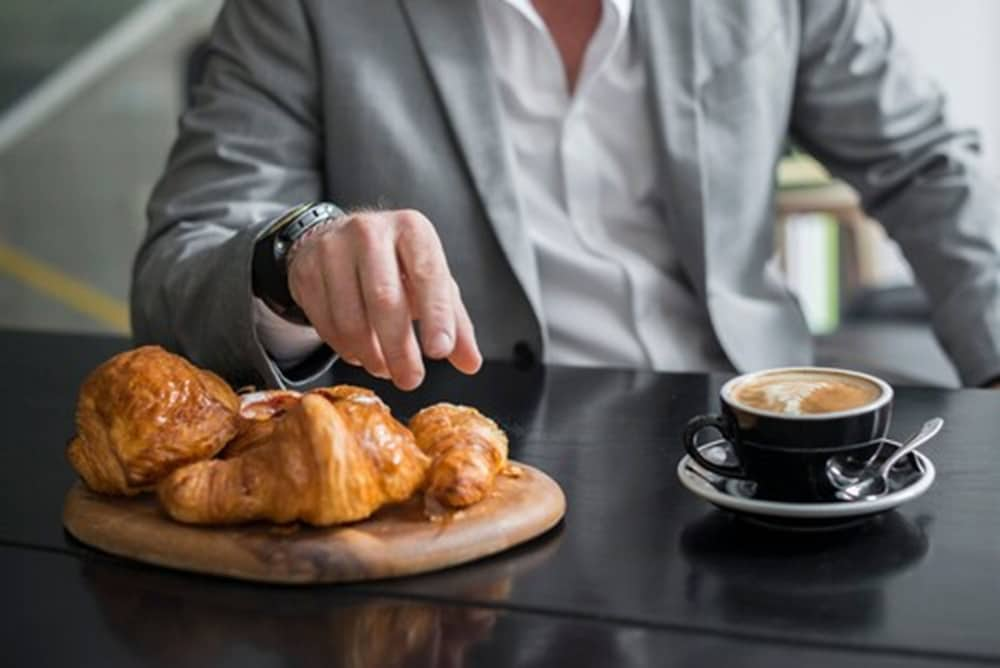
[288,211,482,390]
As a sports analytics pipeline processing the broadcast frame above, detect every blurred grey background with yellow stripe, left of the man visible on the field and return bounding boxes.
[0,0,221,334]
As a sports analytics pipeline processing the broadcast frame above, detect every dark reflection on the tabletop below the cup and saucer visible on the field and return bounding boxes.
[680,512,930,633]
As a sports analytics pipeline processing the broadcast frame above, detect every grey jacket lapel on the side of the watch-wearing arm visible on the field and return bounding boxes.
[400,0,544,336]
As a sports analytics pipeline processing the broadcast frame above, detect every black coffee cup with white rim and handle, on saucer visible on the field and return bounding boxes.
[683,367,893,502]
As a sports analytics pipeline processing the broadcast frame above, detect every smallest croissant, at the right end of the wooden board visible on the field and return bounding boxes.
[410,403,507,508]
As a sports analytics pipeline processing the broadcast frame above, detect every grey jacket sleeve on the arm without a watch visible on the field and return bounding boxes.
[791,0,1000,385]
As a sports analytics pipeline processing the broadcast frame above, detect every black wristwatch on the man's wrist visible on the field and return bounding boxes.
[252,202,340,325]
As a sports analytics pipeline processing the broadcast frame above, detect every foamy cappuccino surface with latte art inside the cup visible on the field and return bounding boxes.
[729,371,882,415]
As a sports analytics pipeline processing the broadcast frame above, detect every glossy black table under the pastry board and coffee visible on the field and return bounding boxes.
[0,332,1000,667]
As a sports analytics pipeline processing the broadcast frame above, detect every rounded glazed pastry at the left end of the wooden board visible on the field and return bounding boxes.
[66,346,240,495]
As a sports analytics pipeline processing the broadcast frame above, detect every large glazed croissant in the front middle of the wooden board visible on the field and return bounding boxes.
[157,387,429,526]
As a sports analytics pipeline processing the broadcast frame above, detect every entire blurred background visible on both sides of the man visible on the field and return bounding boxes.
[0,0,1000,385]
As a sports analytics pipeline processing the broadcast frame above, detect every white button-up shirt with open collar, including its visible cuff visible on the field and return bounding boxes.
[256,0,731,371]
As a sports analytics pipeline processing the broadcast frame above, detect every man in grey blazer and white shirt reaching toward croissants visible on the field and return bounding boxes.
[132,0,1000,389]
